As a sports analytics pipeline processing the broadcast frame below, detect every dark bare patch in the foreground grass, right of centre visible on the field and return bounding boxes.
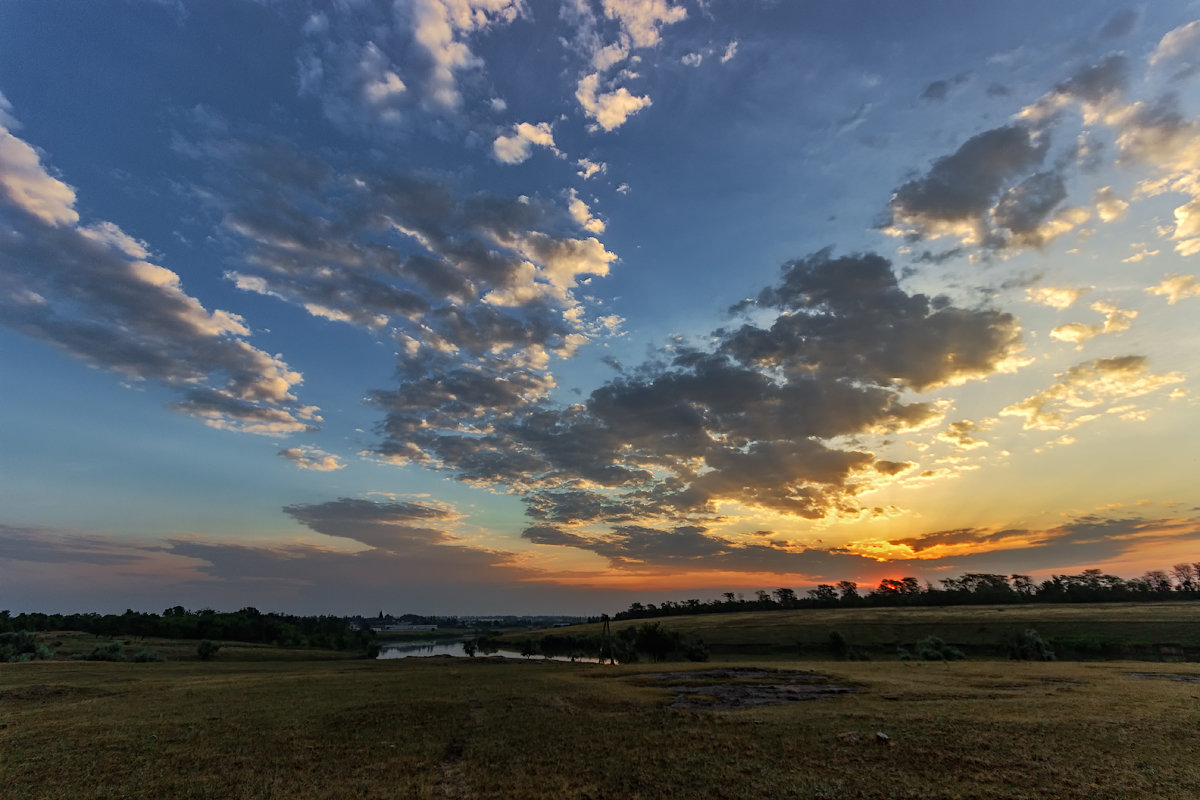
[625,668,862,711]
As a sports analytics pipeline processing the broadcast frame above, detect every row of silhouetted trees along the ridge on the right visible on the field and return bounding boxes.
[613,561,1200,619]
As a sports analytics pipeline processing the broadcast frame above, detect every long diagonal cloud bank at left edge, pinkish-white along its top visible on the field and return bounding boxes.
[0,112,319,434]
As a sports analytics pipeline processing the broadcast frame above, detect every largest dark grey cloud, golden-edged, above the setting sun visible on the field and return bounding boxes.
[376,251,1021,524]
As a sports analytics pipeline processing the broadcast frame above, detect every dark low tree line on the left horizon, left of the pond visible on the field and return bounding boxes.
[0,606,374,650]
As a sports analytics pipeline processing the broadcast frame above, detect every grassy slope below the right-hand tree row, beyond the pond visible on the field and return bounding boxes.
[520,602,1200,660]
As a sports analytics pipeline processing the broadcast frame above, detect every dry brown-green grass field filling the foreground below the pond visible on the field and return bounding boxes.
[0,658,1200,800]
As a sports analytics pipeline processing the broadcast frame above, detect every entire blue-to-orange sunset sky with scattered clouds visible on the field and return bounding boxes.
[0,0,1200,614]
